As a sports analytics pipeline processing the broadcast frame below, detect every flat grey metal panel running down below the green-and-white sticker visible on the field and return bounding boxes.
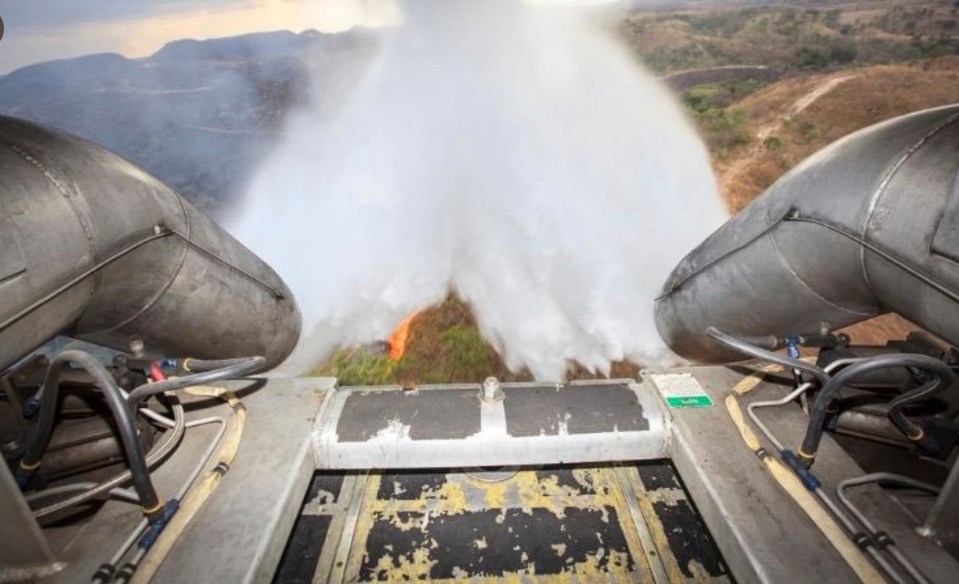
[644,367,856,584]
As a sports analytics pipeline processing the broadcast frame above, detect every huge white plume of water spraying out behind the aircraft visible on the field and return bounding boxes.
[232,0,725,379]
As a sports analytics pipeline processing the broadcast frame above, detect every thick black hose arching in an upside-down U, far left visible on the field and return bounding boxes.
[20,350,162,517]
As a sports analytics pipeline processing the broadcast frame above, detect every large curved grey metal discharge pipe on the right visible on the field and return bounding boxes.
[656,105,959,362]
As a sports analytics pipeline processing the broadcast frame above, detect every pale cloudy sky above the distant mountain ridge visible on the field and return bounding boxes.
[0,0,632,75]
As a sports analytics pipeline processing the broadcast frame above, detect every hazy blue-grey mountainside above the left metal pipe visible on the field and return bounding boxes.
[0,31,376,215]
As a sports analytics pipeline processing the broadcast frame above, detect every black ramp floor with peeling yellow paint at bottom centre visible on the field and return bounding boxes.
[274,461,730,583]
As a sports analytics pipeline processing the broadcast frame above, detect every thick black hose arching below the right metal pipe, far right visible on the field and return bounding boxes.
[798,353,955,466]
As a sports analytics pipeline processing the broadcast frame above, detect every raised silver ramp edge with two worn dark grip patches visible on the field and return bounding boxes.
[314,380,666,470]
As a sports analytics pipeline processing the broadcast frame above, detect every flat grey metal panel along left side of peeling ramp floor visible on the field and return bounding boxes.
[155,378,333,583]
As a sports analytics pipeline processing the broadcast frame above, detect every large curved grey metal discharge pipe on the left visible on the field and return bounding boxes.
[0,117,300,370]
